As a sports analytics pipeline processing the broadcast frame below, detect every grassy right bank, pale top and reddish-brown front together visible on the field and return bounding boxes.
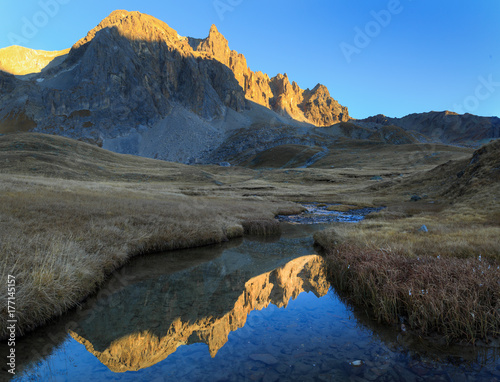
[315,217,500,342]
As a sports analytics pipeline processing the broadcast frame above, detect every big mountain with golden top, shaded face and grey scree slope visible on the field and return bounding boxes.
[0,10,348,152]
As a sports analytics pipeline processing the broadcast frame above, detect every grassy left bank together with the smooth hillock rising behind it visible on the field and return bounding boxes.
[0,134,298,335]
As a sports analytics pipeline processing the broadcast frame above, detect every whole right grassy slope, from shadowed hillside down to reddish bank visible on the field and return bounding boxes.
[315,141,500,342]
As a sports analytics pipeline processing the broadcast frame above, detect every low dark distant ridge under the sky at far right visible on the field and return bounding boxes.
[361,111,500,145]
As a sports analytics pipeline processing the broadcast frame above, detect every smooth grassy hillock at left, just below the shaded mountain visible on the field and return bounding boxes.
[0,133,214,183]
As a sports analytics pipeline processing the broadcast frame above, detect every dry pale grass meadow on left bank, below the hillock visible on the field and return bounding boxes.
[0,175,294,335]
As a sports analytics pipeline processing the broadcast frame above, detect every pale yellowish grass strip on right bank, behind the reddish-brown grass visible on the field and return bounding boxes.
[325,207,500,262]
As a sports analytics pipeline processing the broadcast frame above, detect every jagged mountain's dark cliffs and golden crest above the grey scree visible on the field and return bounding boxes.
[2,11,349,128]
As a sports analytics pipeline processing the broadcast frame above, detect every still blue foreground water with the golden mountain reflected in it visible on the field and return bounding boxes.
[2,218,500,381]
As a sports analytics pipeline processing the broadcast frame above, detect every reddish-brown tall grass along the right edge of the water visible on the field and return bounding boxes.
[318,244,500,343]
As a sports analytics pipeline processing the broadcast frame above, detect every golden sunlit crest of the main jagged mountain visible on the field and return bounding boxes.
[70,10,349,126]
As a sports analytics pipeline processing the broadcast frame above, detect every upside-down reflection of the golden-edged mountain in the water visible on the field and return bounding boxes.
[71,255,329,372]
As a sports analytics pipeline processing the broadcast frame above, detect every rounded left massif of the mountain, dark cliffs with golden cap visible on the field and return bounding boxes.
[0,11,247,142]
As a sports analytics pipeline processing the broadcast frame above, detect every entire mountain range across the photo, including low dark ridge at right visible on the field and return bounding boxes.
[0,10,500,163]
